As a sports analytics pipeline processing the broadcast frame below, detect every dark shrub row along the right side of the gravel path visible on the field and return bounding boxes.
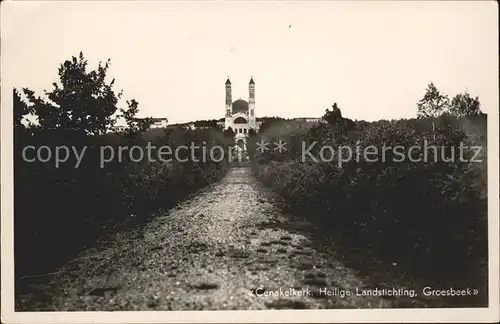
[253,115,487,277]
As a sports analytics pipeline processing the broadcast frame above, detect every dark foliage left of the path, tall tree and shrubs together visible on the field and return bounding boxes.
[13,53,231,277]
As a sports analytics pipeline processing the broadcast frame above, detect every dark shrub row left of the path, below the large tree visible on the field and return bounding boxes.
[14,129,228,277]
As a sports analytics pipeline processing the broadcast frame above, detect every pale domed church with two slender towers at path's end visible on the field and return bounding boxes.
[217,78,260,144]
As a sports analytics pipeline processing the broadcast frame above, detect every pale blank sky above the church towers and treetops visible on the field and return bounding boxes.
[1,1,499,123]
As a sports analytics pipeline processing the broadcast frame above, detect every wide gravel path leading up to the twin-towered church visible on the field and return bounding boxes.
[16,168,428,311]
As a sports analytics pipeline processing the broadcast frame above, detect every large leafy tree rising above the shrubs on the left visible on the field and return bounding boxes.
[23,52,121,135]
